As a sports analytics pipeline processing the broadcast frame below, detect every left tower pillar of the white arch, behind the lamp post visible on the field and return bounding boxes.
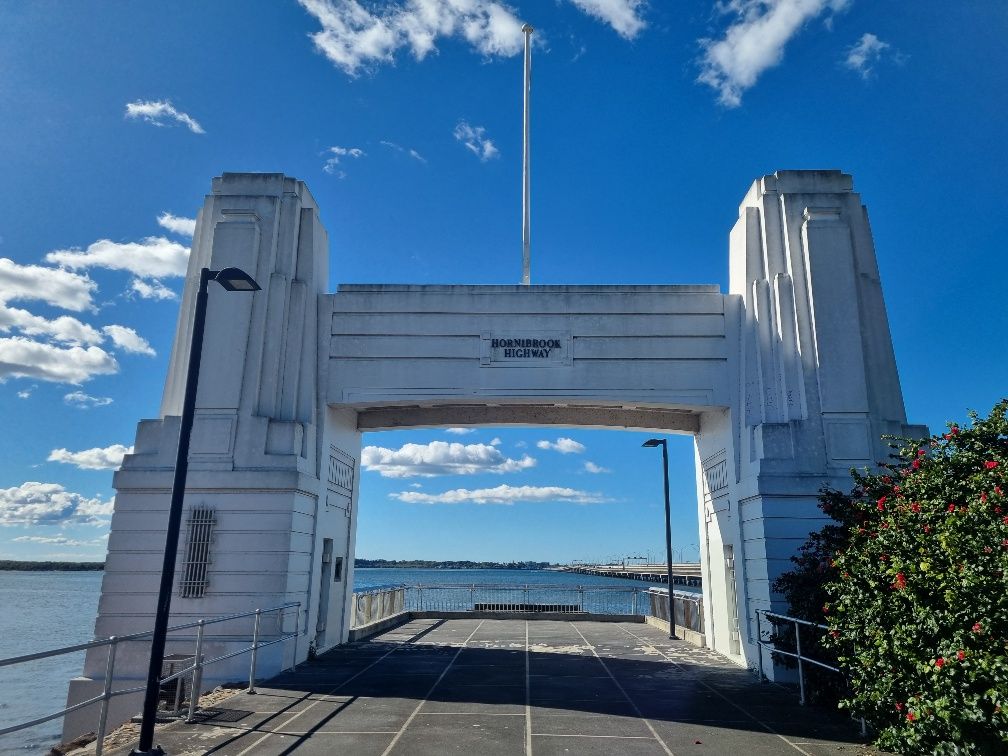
[64,173,360,737]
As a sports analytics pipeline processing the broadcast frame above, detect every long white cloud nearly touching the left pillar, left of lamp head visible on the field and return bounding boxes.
[45,236,190,278]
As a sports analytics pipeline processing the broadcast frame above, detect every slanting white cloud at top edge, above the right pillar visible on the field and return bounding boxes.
[698,0,850,108]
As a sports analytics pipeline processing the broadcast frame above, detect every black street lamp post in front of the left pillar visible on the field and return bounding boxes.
[130,268,260,756]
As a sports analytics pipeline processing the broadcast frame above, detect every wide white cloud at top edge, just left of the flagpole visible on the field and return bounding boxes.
[298,0,524,77]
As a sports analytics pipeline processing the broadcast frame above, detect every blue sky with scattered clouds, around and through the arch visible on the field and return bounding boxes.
[0,0,1008,560]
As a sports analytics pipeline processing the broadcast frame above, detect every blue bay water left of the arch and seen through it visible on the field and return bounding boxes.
[0,568,699,754]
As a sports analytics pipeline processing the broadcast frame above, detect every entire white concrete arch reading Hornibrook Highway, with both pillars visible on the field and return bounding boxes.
[66,170,926,735]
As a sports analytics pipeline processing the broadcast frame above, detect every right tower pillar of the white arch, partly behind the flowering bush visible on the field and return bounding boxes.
[697,170,927,664]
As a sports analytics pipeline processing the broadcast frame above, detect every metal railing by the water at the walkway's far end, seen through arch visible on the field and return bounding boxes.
[353,583,647,628]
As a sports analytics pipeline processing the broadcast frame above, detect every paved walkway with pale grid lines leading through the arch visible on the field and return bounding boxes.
[112,619,872,756]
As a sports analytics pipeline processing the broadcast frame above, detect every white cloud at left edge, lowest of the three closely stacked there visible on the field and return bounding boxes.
[0,337,119,384]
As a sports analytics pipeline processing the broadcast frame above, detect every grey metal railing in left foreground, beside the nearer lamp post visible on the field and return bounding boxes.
[0,602,300,756]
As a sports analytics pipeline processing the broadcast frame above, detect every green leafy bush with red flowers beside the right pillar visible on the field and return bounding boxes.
[817,400,1008,755]
